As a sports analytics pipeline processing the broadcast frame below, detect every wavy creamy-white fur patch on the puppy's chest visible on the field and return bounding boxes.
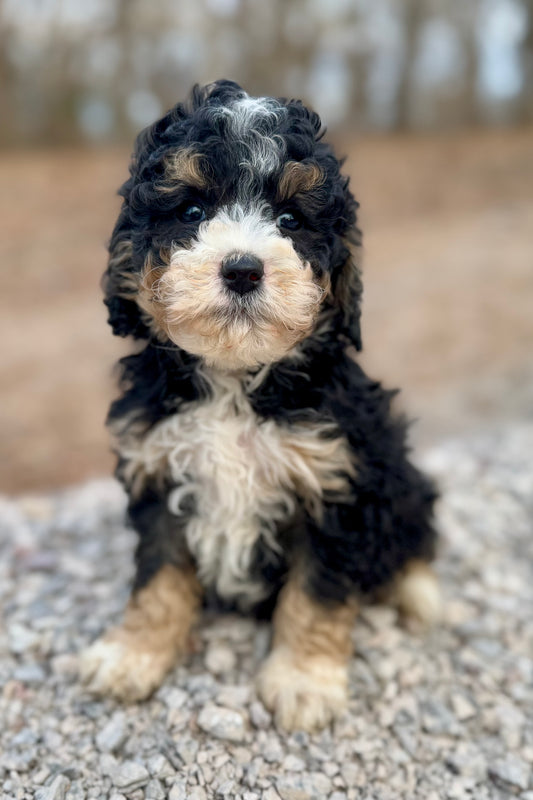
[123,374,354,601]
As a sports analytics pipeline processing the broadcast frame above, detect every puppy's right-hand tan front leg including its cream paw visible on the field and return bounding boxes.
[257,578,357,731]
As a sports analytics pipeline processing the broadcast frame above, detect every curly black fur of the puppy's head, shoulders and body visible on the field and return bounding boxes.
[103,81,435,604]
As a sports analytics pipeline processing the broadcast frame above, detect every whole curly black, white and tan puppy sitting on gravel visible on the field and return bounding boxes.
[81,81,439,730]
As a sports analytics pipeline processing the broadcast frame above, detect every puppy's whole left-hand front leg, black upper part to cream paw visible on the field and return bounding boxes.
[80,485,202,702]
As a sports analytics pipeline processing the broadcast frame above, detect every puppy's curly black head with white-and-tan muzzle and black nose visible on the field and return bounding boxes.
[104,82,362,370]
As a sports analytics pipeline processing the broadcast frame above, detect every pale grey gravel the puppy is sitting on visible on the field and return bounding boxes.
[0,426,533,800]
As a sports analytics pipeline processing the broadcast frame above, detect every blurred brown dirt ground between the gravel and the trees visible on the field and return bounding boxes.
[0,129,533,493]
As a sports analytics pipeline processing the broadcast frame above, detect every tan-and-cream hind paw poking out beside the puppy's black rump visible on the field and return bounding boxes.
[390,559,442,630]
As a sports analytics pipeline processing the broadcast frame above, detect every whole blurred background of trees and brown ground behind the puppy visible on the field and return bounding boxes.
[0,0,533,493]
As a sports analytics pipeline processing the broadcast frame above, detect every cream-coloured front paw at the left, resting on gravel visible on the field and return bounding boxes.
[80,628,176,703]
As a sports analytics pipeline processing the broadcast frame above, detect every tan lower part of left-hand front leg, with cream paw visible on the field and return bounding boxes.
[80,564,201,702]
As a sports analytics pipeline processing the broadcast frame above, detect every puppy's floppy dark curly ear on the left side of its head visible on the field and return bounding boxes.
[102,203,149,339]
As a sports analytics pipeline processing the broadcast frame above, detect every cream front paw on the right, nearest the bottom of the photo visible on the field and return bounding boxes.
[257,647,348,732]
